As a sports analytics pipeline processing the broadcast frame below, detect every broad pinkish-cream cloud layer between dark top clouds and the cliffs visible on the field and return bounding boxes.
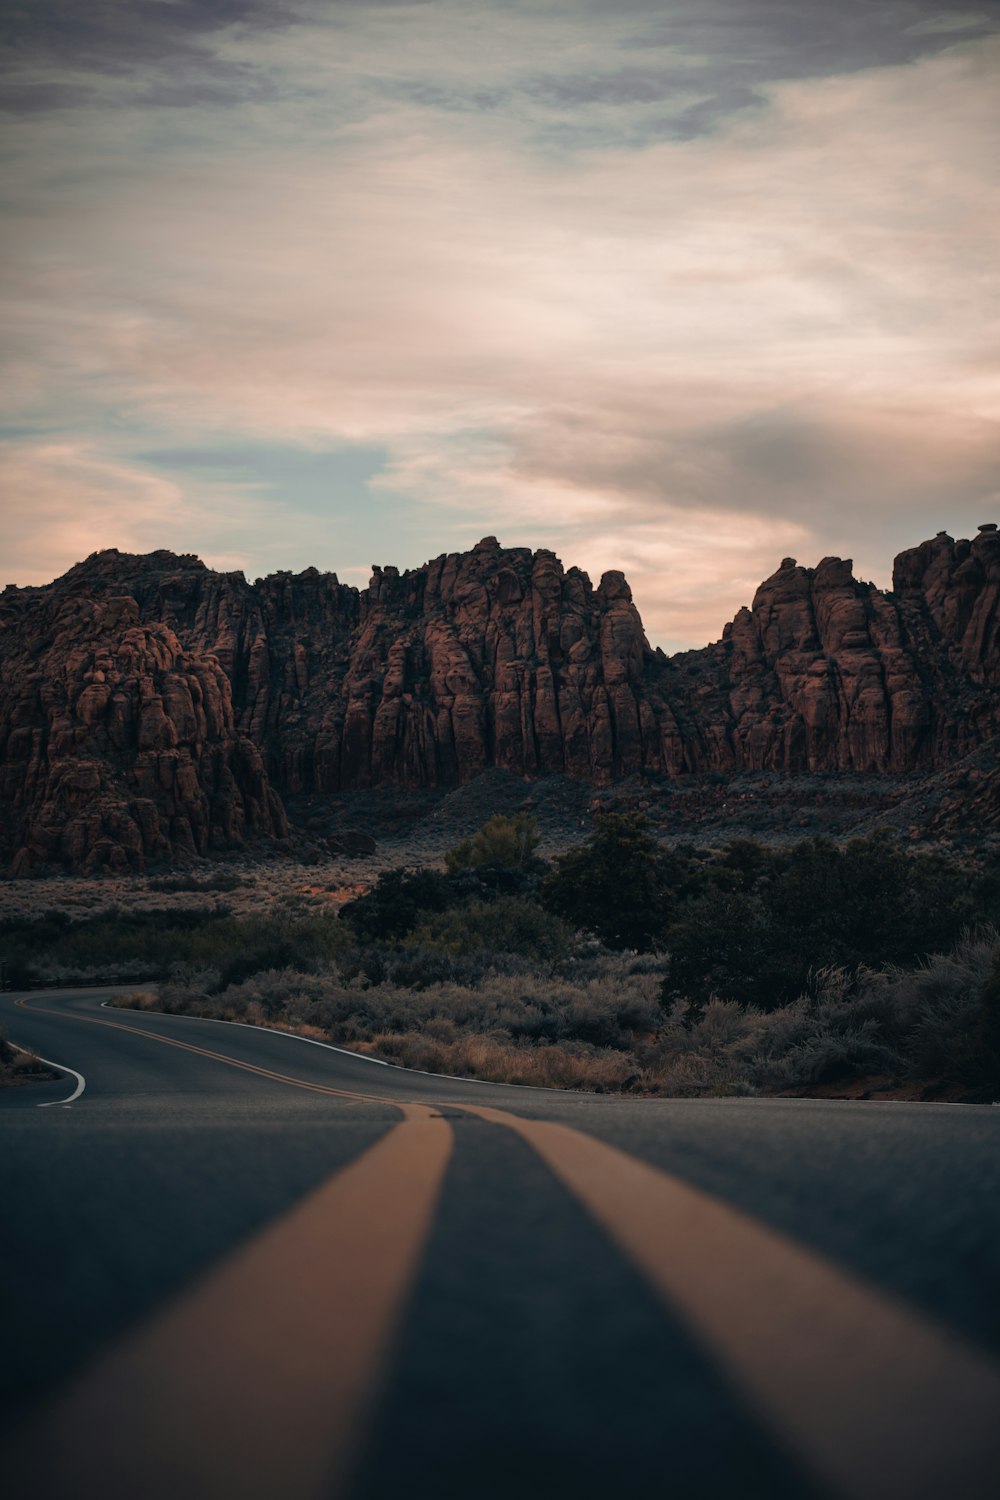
[4,21,1000,644]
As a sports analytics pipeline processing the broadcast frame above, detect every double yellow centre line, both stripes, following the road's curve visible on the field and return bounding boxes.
[7,1011,1000,1500]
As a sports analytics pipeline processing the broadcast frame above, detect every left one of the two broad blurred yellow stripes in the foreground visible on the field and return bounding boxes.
[4,1104,453,1500]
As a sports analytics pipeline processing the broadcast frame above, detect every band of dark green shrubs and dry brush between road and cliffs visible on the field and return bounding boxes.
[9,813,1000,1098]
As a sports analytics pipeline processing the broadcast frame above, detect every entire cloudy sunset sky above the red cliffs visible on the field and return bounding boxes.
[0,0,1000,648]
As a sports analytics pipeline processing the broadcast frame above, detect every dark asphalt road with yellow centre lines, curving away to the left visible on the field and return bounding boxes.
[0,990,1000,1500]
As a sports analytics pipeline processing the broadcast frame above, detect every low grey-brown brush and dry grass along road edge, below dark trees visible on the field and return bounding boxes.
[118,929,1000,1098]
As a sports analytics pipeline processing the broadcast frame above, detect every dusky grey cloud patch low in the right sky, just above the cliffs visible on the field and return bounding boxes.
[513,404,1000,567]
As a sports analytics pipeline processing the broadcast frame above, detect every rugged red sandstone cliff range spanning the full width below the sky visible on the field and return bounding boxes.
[0,525,1000,875]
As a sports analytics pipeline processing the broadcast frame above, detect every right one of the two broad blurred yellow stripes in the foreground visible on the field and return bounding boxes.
[462,1104,1000,1500]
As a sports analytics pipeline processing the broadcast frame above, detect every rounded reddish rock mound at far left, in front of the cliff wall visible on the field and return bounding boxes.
[0,573,288,875]
